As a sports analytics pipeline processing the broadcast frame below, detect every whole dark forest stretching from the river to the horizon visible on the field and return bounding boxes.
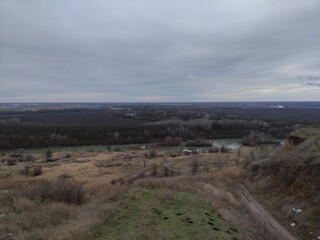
[0,104,320,149]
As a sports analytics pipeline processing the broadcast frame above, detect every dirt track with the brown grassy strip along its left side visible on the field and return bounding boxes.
[205,182,298,240]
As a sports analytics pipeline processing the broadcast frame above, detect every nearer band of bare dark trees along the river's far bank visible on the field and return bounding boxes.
[0,119,292,149]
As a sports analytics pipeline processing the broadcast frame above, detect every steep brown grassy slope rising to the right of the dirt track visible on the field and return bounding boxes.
[249,135,320,239]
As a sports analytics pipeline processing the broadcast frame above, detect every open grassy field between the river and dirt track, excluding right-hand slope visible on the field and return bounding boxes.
[0,141,296,240]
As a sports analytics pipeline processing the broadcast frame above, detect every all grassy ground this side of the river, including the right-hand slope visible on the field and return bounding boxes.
[0,124,320,240]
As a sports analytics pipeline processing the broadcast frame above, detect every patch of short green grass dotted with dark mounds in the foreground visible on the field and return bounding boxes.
[97,189,244,240]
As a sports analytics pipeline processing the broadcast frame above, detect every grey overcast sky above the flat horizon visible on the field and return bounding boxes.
[0,0,320,102]
